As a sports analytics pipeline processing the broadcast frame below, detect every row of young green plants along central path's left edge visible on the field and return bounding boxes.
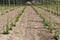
[3,6,26,34]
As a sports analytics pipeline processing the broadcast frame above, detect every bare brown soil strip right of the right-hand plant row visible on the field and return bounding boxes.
[35,7,60,31]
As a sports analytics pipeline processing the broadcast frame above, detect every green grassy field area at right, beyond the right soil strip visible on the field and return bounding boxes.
[37,4,60,16]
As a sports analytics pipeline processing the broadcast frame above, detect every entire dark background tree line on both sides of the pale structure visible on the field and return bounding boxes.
[0,0,60,4]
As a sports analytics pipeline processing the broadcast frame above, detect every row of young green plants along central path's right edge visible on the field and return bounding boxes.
[31,6,59,40]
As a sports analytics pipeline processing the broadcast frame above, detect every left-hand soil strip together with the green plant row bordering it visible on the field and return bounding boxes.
[0,6,25,34]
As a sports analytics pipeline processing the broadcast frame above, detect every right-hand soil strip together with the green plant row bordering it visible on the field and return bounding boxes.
[33,6,60,40]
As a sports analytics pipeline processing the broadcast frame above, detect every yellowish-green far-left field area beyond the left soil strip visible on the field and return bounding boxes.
[0,6,19,15]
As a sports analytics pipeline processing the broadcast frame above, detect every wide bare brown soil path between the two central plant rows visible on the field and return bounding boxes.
[1,6,54,40]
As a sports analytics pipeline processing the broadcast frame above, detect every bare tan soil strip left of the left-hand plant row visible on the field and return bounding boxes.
[0,7,24,34]
